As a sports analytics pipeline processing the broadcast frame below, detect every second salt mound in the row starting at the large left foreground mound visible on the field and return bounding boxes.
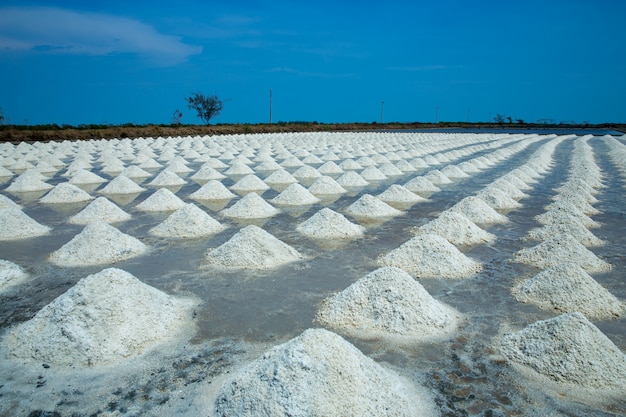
[205,225,301,269]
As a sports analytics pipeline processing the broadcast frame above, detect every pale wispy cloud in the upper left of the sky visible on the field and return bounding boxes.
[0,7,202,65]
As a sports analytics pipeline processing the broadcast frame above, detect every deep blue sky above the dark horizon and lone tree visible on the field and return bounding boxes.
[0,0,626,125]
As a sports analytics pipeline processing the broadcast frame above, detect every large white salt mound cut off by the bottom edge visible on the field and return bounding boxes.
[213,329,438,417]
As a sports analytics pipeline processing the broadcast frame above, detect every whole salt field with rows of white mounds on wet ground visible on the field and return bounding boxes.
[0,132,626,416]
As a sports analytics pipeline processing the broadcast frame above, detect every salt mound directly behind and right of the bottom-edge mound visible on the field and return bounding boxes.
[316,267,460,341]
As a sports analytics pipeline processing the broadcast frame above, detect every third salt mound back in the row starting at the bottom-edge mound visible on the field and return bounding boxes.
[378,234,482,278]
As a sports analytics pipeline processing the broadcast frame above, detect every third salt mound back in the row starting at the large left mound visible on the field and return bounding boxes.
[296,207,365,240]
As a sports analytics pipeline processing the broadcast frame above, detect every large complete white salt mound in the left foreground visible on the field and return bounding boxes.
[4,268,191,367]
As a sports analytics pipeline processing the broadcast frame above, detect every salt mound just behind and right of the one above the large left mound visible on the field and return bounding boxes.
[149,204,225,238]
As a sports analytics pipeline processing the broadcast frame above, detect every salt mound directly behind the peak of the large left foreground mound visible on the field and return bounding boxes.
[49,221,148,267]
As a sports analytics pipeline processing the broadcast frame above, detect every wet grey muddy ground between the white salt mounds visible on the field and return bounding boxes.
[0,133,626,416]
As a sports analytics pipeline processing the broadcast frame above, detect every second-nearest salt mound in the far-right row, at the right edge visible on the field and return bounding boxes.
[512,263,626,319]
